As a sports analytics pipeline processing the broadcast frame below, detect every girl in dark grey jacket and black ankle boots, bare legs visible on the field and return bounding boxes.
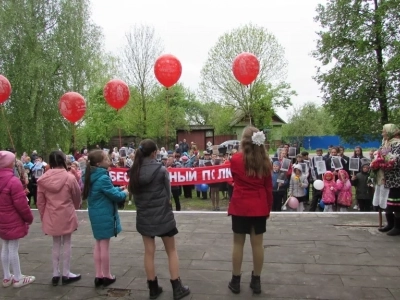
[129,139,190,299]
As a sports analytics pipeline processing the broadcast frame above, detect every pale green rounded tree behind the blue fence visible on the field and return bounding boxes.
[282,102,336,143]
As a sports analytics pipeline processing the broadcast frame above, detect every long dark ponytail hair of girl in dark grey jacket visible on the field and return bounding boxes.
[129,139,157,191]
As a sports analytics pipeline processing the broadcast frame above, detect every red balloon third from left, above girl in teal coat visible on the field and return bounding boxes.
[103,79,130,109]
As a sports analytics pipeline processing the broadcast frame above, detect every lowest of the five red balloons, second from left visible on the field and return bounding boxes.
[58,92,86,123]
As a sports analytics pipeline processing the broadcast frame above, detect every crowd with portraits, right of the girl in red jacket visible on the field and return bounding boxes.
[272,144,376,212]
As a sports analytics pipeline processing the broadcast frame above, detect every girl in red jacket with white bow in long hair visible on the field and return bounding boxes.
[228,127,273,294]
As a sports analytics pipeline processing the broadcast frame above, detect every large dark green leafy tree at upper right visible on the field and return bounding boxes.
[313,0,400,141]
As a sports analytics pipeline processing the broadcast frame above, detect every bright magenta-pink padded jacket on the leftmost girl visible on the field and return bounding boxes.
[0,168,33,240]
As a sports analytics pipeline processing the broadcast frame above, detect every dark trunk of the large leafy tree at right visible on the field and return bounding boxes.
[374,0,389,126]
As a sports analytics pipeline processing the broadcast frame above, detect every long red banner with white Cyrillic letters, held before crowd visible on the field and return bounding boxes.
[109,165,232,186]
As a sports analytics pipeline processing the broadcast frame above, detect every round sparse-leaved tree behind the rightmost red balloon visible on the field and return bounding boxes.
[200,24,295,127]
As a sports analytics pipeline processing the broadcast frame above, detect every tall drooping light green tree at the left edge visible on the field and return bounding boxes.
[0,0,103,154]
